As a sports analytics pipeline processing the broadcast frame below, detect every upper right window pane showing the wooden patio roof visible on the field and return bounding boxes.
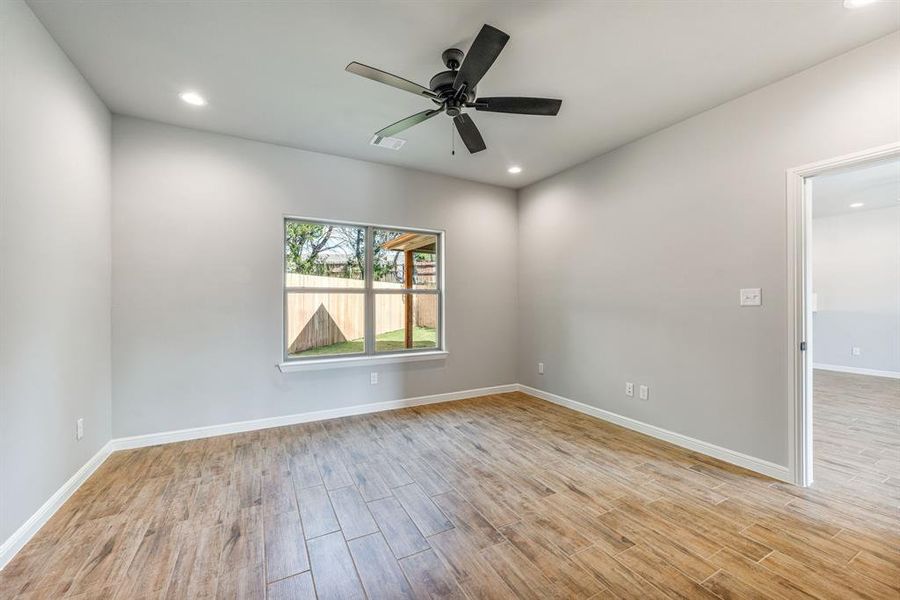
[372,229,437,289]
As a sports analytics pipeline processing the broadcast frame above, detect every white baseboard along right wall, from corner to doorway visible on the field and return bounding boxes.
[519,384,793,483]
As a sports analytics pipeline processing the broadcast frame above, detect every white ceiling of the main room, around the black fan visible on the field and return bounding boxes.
[29,0,900,188]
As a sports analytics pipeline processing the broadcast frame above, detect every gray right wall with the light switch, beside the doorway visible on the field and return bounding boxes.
[518,34,900,465]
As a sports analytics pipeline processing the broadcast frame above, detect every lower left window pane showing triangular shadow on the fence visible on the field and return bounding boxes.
[285,292,366,358]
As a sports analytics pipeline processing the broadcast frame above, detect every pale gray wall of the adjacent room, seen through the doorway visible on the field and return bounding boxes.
[811,209,900,375]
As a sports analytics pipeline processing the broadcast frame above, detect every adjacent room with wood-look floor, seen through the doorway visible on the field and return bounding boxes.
[809,157,900,492]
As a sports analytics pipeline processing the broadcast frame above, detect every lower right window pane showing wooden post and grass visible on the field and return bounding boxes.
[375,294,438,352]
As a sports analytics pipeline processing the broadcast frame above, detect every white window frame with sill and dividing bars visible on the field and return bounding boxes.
[278,215,448,373]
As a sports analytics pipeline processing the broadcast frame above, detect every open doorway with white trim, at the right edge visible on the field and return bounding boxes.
[788,144,900,494]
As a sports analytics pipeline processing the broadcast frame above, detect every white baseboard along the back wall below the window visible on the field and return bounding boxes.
[112,383,518,450]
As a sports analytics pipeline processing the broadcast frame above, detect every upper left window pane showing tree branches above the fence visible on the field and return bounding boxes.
[284,220,366,288]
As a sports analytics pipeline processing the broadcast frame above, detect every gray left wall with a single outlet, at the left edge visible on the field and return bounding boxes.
[0,0,110,541]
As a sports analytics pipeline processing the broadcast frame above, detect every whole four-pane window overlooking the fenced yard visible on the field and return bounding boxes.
[284,218,443,363]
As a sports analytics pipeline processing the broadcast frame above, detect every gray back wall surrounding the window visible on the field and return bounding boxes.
[113,117,517,437]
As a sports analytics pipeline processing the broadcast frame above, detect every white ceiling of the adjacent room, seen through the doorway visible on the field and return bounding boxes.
[812,158,900,218]
